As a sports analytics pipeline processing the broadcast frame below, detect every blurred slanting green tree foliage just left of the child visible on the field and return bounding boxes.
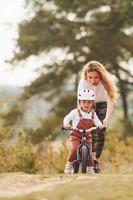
[22,93,76,144]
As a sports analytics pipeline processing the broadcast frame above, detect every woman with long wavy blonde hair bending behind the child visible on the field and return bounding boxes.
[78,61,118,173]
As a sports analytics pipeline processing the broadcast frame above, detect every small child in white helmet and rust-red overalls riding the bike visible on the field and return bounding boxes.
[63,89,103,174]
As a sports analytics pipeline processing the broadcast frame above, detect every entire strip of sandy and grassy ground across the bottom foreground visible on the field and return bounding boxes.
[0,173,133,200]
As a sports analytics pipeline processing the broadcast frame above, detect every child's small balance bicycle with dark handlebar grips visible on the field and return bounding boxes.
[62,127,98,174]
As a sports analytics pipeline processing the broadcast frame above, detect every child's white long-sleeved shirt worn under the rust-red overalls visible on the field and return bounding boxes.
[63,109,102,128]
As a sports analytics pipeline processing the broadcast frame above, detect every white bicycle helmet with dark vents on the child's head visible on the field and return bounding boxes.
[78,89,95,100]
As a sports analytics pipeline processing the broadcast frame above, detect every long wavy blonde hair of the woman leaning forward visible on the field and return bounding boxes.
[82,61,118,102]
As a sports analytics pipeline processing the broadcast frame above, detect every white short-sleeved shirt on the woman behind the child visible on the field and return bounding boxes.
[78,79,108,103]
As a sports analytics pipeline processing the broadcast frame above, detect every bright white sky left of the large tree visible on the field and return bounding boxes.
[0,0,39,86]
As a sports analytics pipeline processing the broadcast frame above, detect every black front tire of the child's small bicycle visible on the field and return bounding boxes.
[82,146,88,173]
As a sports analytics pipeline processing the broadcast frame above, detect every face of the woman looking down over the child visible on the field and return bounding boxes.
[87,71,100,86]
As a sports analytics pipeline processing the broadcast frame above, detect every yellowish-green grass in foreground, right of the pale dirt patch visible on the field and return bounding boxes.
[0,174,133,200]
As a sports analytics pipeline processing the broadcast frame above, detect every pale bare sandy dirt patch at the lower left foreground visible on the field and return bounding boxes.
[0,173,71,198]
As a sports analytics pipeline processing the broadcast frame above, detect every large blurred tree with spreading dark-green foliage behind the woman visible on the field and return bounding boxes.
[4,0,133,141]
